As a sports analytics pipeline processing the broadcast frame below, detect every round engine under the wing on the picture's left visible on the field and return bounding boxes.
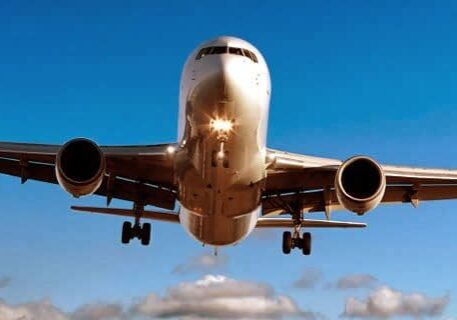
[56,138,106,198]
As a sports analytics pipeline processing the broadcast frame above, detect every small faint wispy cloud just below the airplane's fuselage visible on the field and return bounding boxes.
[173,253,229,274]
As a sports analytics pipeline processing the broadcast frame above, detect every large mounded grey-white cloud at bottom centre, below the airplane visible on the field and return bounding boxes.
[131,275,315,319]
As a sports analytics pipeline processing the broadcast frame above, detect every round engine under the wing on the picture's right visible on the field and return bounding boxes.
[335,156,386,215]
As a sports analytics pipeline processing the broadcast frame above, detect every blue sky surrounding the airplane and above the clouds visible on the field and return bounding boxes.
[0,0,457,319]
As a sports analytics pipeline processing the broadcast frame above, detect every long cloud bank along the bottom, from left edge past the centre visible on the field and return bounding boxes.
[0,275,320,320]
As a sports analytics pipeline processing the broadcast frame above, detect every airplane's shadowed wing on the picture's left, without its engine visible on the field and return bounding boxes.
[0,142,176,210]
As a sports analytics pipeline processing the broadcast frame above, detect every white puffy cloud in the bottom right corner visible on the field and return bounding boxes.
[343,286,449,318]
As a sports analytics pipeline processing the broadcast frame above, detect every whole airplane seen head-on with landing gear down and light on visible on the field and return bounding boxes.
[0,36,457,255]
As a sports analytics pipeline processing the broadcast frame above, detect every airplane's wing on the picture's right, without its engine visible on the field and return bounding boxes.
[262,149,457,215]
